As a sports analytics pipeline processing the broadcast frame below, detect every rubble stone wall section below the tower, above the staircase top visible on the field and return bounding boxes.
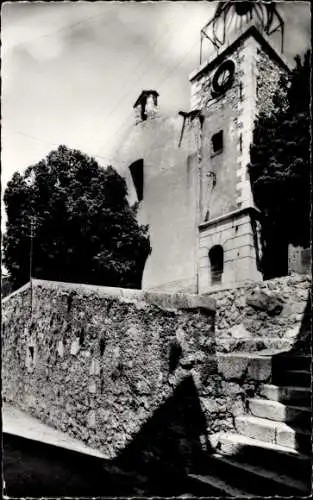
[202,274,311,352]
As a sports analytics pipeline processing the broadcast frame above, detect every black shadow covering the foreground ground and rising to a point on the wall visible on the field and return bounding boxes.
[3,375,216,497]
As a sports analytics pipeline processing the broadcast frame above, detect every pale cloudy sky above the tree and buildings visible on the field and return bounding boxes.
[1,1,311,227]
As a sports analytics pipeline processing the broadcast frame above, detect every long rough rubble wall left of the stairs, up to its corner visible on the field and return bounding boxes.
[2,280,215,478]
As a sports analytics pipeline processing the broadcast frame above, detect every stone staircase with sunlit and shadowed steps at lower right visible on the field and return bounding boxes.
[186,354,312,497]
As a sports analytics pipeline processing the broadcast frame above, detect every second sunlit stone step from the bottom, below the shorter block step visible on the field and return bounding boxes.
[235,415,311,454]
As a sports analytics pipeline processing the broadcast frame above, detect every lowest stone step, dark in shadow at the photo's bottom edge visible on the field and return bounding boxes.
[188,474,253,498]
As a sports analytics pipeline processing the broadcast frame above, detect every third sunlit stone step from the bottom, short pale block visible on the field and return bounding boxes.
[247,398,311,429]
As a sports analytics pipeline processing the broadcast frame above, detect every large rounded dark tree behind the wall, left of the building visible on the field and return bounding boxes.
[3,146,151,288]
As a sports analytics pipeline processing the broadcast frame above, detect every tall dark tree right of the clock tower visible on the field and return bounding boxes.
[249,52,311,279]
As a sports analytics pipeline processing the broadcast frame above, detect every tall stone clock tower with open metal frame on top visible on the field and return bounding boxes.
[190,2,289,293]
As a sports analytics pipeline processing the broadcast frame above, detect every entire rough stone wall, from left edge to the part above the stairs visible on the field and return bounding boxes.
[2,276,310,488]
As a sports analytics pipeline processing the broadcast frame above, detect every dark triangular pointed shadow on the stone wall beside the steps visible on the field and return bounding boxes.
[111,375,212,496]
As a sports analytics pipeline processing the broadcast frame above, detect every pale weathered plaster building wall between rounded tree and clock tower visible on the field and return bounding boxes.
[117,116,199,292]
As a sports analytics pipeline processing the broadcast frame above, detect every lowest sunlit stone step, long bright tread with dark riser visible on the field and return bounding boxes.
[216,432,311,480]
